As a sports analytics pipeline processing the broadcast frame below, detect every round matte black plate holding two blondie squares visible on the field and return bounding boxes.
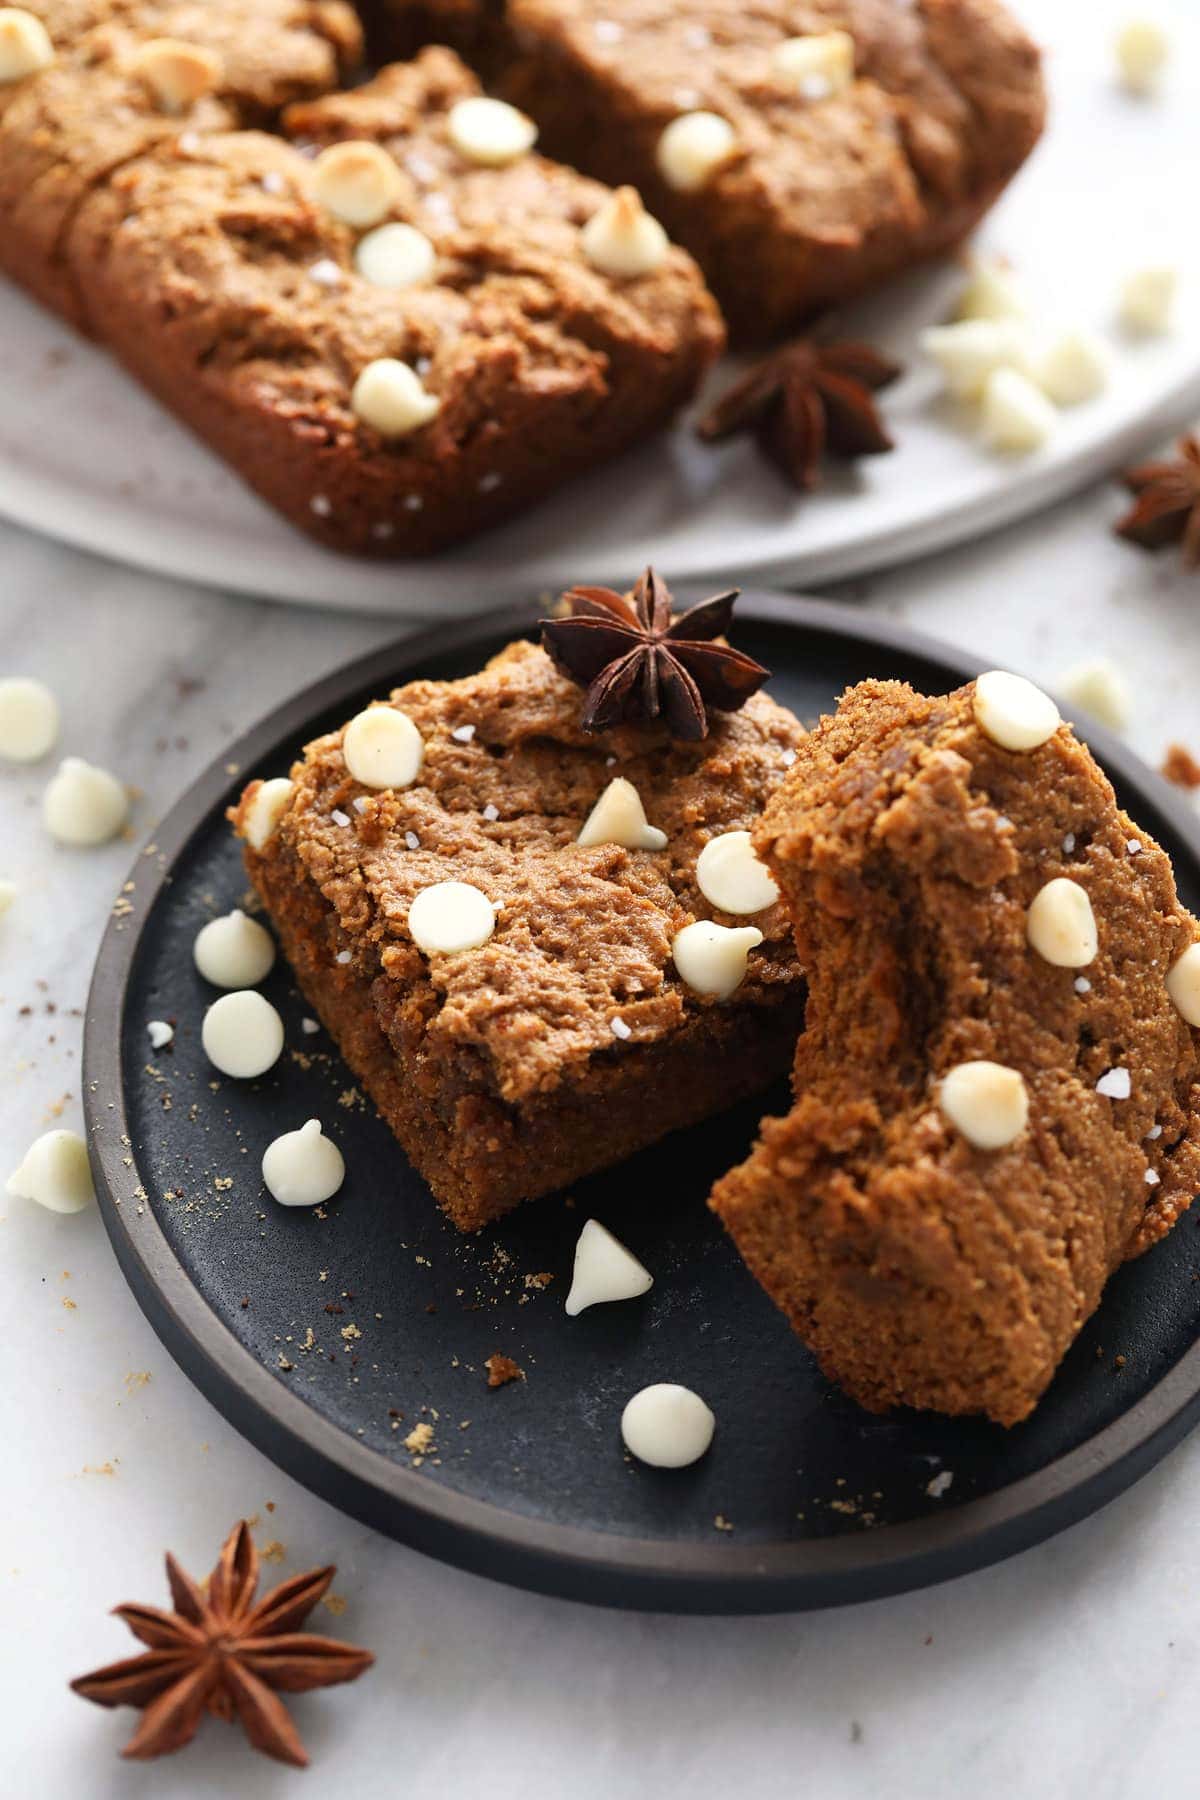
[85,596,1200,1611]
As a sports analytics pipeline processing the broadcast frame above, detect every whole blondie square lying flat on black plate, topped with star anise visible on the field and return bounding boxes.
[234,643,802,1231]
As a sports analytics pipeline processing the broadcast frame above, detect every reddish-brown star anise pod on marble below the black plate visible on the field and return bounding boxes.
[70,1519,374,1769]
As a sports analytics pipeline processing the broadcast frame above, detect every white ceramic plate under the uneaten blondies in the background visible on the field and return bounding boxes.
[0,0,1200,619]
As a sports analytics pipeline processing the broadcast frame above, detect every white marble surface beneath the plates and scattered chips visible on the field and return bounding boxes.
[0,460,1200,1800]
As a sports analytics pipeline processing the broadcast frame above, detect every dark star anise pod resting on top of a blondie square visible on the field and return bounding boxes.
[542,569,770,740]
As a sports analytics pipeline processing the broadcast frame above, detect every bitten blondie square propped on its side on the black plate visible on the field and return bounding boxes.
[712,675,1200,1424]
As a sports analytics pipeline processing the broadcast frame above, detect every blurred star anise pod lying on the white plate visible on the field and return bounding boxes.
[696,338,901,491]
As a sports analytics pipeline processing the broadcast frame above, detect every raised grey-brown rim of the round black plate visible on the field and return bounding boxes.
[81,585,1200,1613]
